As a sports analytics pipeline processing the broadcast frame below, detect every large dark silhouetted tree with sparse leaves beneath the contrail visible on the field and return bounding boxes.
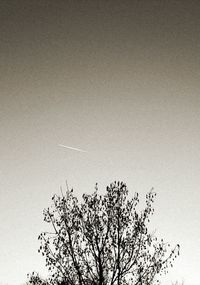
[28,182,179,285]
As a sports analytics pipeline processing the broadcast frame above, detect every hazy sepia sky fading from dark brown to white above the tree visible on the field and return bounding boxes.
[0,0,200,285]
